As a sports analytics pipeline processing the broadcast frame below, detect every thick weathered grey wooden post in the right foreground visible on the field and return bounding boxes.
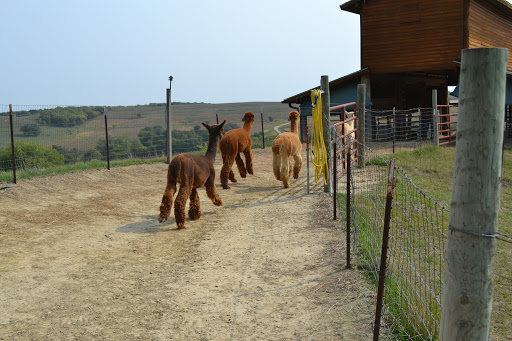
[439,48,508,341]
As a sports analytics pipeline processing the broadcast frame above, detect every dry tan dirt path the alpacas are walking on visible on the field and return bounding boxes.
[0,149,371,340]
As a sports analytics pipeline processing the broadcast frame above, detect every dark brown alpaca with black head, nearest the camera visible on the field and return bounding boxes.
[158,120,226,229]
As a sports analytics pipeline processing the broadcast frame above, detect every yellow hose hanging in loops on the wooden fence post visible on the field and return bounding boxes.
[311,90,329,185]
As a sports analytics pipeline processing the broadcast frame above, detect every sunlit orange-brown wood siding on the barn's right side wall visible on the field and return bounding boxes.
[466,0,512,71]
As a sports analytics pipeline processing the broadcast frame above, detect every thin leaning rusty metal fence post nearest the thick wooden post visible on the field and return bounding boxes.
[373,158,396,341]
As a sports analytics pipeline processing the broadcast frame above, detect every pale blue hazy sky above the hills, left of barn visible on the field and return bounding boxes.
[0,0,360,105]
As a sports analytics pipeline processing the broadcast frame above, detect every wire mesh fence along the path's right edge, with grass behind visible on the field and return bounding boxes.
[333,137,512,340]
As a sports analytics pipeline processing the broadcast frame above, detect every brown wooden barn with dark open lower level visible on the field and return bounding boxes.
[283,0,512,115]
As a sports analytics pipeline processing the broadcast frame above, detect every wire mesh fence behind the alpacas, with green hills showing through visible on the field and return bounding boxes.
[0,104,288,183]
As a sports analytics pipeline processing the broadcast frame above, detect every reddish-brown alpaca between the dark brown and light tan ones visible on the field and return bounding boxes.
[220,111,254,189]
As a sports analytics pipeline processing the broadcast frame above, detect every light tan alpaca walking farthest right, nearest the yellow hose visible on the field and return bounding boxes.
[272,111,302,188]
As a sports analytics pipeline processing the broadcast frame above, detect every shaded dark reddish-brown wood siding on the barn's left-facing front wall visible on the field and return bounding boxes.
[361,0,464,74]
